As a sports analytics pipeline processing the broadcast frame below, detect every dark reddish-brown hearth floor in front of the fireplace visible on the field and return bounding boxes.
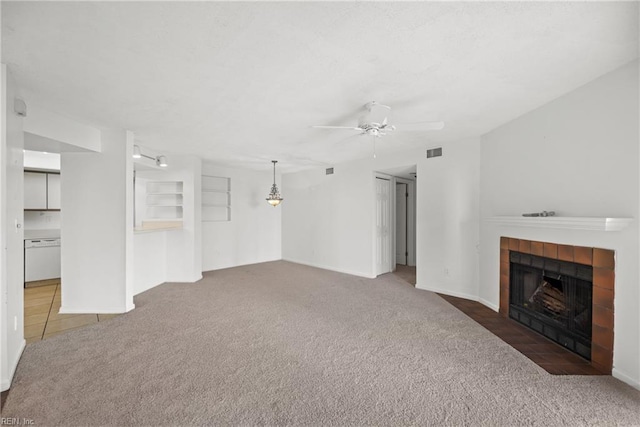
[438,294,605,375]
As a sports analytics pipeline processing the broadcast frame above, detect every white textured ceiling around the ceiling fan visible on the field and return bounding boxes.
[2,1,638,172]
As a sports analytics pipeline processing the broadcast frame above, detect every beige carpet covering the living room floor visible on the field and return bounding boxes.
[2,262,640,426]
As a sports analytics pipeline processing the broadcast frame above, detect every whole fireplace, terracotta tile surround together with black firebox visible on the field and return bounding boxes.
[500,237,615,374]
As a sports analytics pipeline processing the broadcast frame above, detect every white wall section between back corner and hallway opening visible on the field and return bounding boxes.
[281,160,375,277]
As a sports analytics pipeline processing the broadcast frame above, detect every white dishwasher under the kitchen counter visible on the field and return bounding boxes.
[24,238,60,282]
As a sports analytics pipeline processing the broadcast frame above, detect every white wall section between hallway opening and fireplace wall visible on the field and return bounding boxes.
[416,139,480,300]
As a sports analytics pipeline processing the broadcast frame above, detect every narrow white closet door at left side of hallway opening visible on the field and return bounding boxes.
[376,177,392,276]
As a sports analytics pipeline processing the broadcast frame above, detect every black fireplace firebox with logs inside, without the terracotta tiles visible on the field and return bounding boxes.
[509,251,593,360]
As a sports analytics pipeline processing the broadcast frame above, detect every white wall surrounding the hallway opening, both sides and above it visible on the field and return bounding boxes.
[282,139,479,292]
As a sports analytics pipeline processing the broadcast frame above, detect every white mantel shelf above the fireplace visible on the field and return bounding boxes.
[487,216,633,231]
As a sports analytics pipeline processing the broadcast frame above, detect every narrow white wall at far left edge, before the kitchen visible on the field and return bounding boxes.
[0,64,25,391]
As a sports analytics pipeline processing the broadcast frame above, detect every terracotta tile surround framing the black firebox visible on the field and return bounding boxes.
[499,237,615,375]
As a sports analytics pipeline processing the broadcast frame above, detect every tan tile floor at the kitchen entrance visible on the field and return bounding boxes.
[24,283,118,344]
